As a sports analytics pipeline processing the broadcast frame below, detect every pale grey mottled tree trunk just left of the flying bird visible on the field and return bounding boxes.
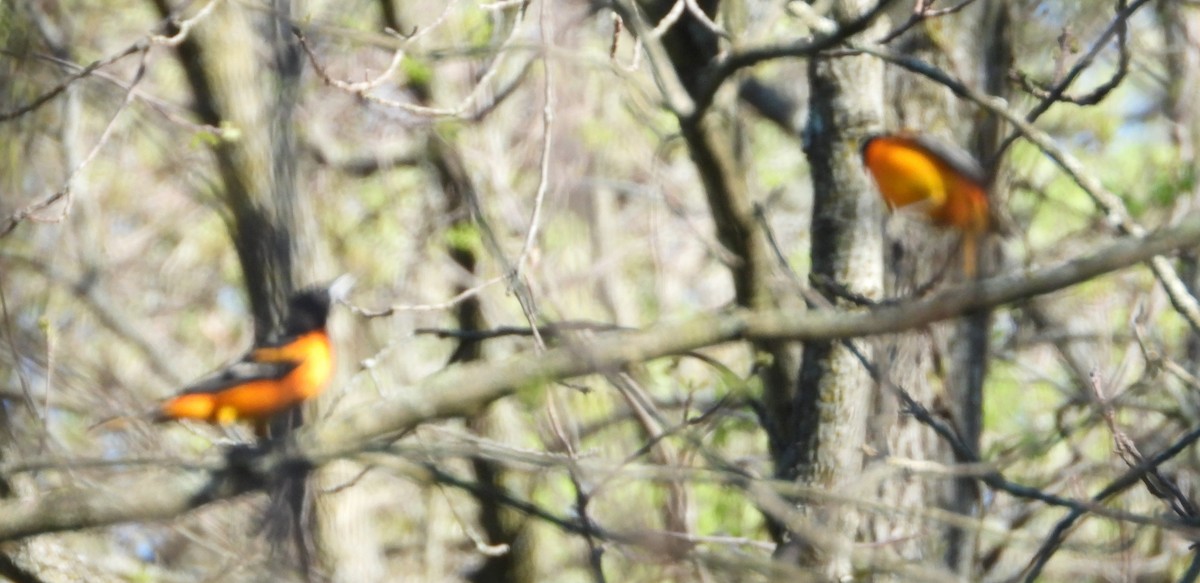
[776,0,883,578]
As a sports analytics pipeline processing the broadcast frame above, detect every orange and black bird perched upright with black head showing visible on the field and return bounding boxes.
[154,278,350,437]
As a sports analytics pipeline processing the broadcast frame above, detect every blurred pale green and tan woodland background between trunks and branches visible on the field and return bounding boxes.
[0,0,1200,582]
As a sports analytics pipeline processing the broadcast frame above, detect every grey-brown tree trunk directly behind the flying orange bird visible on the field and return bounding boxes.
[871,0,1012,578]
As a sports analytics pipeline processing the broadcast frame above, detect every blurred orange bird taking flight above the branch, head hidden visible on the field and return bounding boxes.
[863,133,991,277]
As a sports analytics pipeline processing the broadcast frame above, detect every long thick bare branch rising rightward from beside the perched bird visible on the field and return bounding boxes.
[308,209,1200,455]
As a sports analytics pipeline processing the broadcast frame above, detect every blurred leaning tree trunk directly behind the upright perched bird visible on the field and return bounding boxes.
[155,0,316,576]
